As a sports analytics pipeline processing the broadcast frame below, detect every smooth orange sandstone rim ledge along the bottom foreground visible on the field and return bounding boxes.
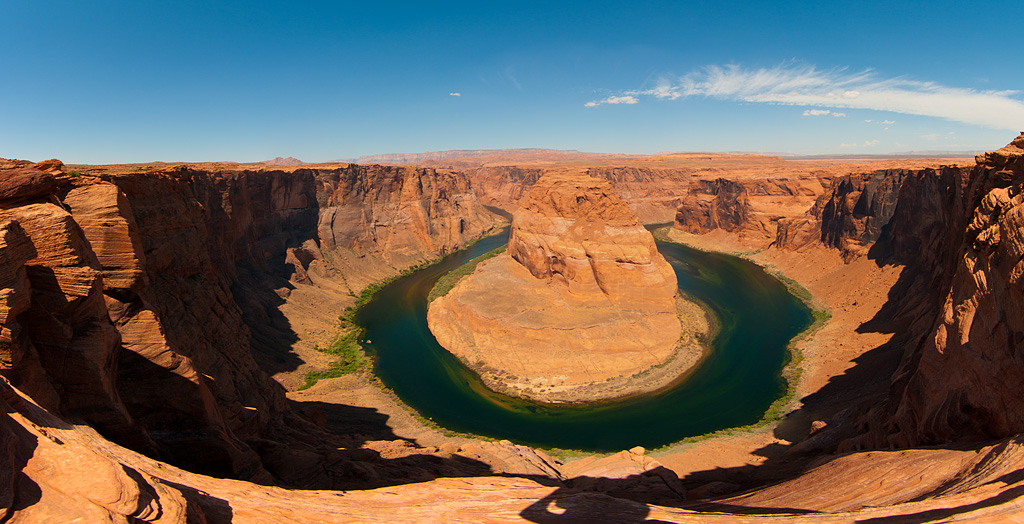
[0,370,1024,524]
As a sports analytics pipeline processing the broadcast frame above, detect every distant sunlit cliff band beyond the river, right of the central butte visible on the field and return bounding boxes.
[674,159,963,252]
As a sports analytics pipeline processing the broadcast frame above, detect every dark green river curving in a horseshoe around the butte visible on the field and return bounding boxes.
[356,232,811,451]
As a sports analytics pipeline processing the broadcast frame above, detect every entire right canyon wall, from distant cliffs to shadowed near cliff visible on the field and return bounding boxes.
[676,145,1024,450]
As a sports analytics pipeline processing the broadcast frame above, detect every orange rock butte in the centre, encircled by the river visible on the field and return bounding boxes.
[427,173,708,403]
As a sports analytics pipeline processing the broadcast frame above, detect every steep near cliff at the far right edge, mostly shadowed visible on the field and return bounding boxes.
[856,133,1024,446]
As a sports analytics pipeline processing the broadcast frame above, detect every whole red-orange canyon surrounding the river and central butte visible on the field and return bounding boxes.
[0,134,1024,522]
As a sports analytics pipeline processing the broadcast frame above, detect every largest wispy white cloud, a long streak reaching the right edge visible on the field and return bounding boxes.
[587,63,1024,131]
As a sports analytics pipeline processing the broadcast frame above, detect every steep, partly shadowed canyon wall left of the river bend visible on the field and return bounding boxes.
[0,161,498,482]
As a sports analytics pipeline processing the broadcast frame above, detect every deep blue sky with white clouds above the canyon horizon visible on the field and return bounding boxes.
[0,0,1024,163]
